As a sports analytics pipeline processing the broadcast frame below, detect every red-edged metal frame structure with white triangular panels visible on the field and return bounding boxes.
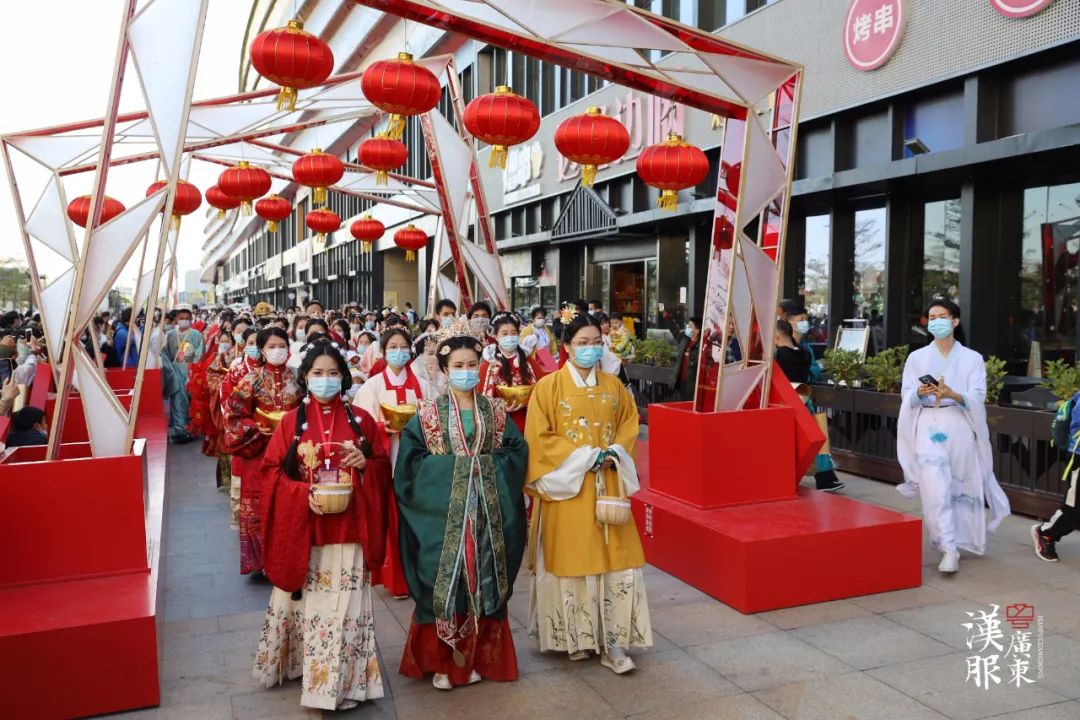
[2,0,801,458]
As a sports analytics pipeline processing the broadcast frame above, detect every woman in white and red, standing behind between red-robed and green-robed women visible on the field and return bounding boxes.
[352,327,431,599]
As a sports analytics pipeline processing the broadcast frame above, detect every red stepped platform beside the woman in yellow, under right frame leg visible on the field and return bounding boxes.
[632,372,922,613]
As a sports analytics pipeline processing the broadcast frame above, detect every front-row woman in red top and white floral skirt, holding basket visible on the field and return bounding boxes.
[252,339,391,710]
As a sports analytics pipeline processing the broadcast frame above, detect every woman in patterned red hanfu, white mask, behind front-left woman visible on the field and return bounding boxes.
[225,327,300,575]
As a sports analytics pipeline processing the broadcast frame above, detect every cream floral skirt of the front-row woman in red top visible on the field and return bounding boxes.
[252,544,382,710]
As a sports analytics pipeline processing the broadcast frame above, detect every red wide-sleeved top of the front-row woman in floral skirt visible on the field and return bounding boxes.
[261,397,391,592]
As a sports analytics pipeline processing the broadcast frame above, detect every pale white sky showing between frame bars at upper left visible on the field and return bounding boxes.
[0,0,259,289]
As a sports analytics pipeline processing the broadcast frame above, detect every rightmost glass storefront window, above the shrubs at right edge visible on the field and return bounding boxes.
[1010,182,1080,372]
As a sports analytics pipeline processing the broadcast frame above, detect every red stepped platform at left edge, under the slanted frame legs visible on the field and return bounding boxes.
[0,373,167,719]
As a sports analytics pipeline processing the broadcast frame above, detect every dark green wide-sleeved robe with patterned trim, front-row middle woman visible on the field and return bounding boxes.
[394,394,528,644]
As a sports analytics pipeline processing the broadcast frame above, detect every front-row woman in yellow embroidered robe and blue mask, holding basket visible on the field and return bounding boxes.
[525,309,652,674]
